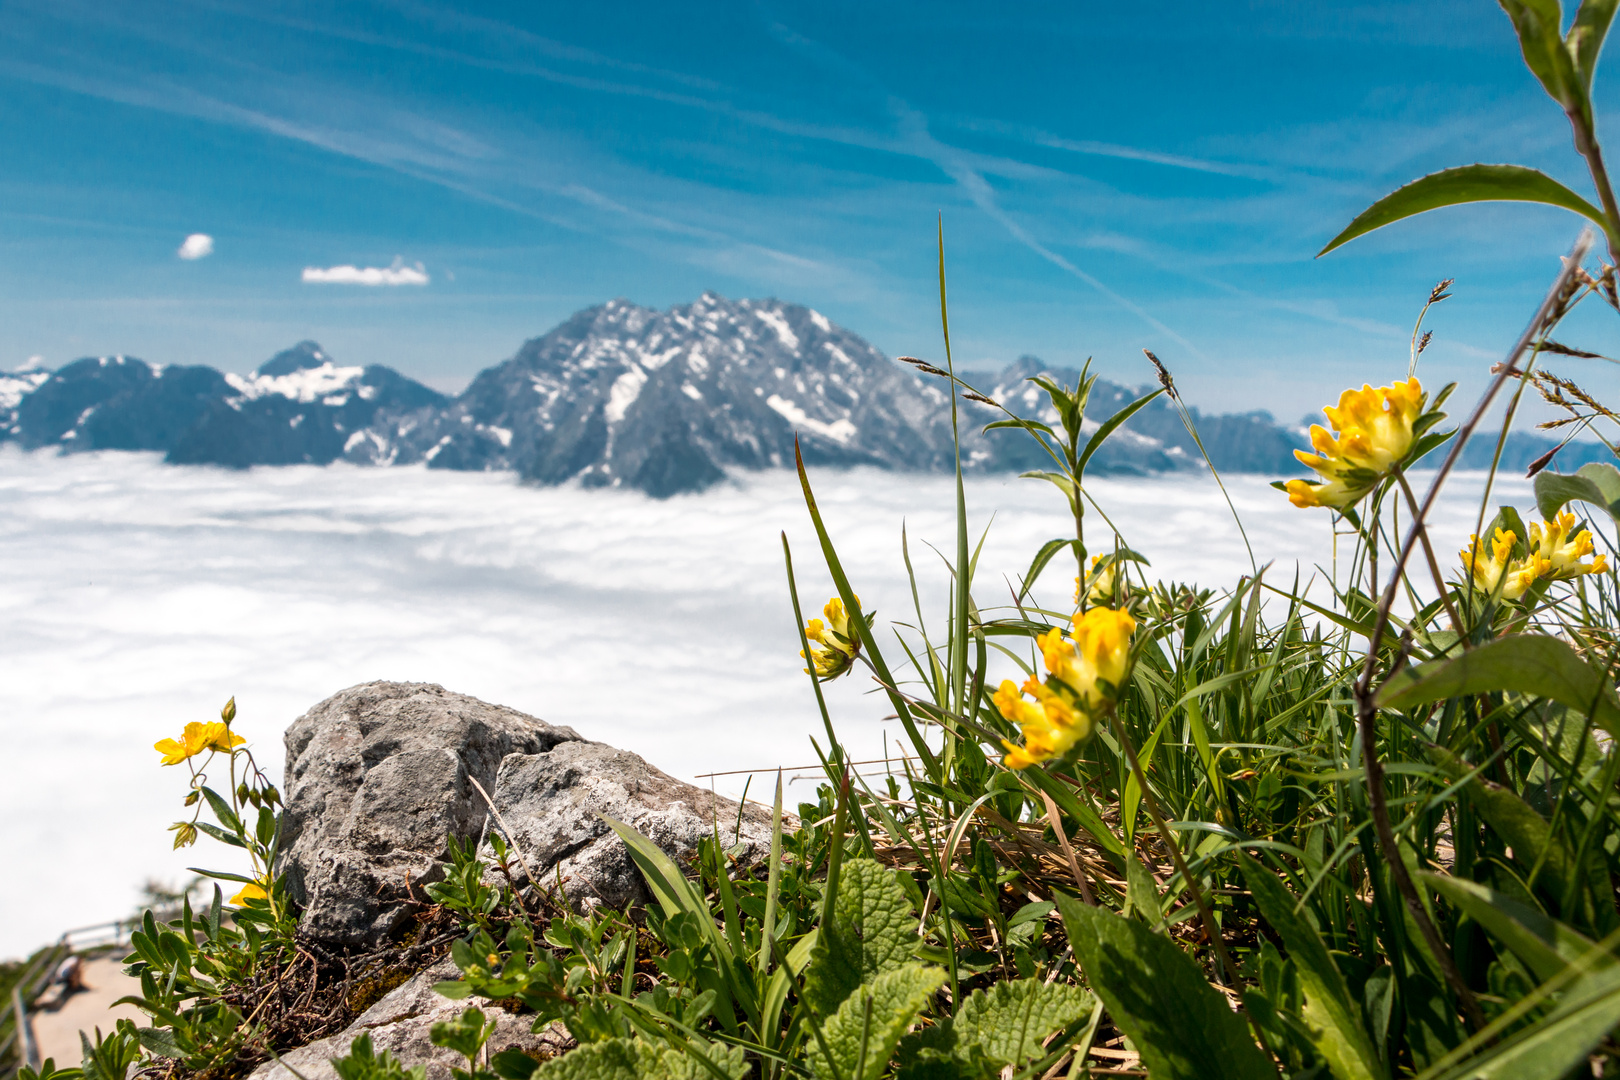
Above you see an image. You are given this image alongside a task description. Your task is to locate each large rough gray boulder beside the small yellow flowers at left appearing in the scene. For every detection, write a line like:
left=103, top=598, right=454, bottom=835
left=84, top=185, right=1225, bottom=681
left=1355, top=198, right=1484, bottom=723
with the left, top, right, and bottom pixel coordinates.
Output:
left=277, top=682, right=770, bottom=946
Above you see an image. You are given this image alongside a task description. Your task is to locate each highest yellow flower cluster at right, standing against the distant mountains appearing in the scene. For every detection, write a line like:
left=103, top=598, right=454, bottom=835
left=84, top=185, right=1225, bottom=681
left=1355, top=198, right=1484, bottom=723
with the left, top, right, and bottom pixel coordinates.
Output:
left=1286, top=377, right=1426, bottom=510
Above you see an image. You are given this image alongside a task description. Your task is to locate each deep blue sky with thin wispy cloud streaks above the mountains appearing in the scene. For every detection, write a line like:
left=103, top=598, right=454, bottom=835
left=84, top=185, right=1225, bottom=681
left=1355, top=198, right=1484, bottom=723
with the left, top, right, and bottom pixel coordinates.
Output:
left=0, top=0, right=1617, bottom=419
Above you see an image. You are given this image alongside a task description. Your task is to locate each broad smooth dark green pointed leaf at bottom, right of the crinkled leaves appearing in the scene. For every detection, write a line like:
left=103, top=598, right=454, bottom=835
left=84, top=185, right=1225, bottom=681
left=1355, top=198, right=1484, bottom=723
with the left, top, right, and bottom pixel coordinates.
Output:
left=1056, top=892, right=1277, bottom=1080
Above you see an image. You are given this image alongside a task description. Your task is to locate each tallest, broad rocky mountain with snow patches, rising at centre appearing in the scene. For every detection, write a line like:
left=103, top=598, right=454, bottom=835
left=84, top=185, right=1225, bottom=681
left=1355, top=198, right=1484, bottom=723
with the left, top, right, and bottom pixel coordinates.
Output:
left=398, top=293, right=949, bottom=495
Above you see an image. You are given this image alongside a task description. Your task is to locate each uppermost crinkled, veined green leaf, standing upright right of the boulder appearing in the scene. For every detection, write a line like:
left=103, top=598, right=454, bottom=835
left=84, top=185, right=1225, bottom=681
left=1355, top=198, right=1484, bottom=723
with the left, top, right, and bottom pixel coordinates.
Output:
left=803, top=858, right=917, bottom=1017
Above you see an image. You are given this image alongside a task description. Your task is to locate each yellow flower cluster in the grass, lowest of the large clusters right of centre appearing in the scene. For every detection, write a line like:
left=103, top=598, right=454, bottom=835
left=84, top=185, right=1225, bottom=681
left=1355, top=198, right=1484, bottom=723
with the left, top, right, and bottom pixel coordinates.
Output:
left=995, top=607, right=1136, bottom=769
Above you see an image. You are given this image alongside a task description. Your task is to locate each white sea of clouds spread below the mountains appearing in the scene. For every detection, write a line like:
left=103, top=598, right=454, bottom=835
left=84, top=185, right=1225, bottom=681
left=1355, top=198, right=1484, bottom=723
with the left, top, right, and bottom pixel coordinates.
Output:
left=0, top=450, right=1531, bottom=957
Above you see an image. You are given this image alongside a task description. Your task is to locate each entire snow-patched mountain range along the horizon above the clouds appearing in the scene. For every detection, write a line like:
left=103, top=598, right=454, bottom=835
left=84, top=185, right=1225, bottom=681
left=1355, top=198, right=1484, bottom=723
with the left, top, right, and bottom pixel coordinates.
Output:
left=0, top=293, right=1607, bottom=497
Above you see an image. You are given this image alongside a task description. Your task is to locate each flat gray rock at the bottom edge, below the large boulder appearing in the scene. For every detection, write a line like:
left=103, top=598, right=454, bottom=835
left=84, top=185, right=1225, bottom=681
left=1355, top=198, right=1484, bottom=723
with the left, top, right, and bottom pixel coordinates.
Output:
left=239, top=960, right=573, bottom=1080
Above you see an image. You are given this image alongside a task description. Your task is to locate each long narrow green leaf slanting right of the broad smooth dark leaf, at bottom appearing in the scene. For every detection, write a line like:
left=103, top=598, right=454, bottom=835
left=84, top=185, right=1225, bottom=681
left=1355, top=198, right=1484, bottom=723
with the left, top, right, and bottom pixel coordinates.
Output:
left=1238, top=853, right=1388, bottom=1080
